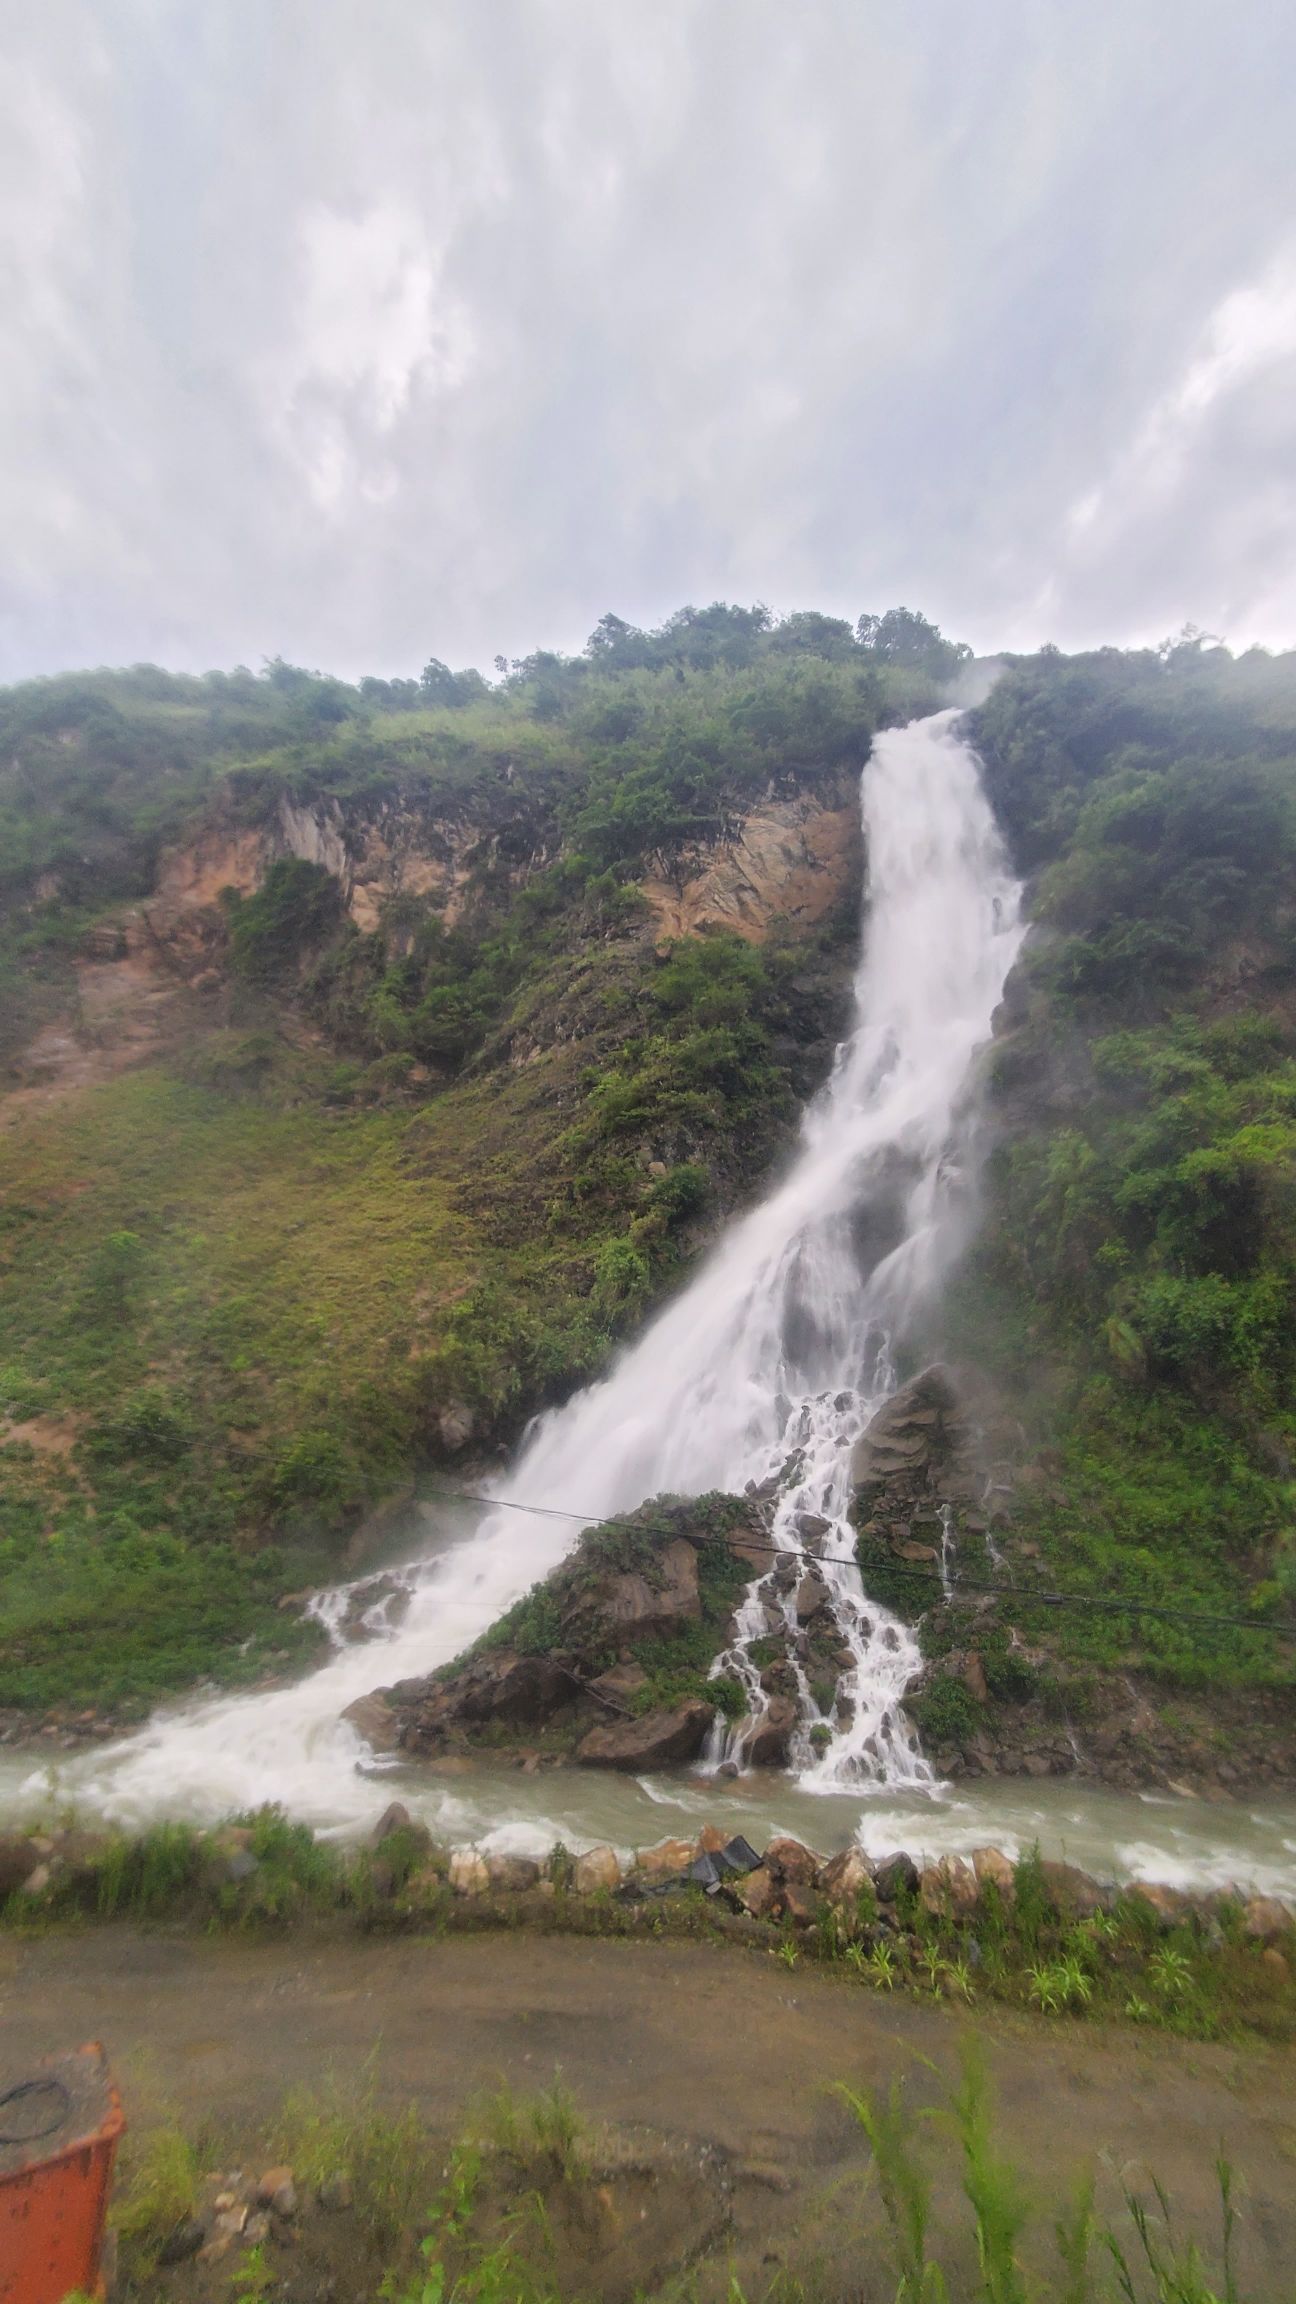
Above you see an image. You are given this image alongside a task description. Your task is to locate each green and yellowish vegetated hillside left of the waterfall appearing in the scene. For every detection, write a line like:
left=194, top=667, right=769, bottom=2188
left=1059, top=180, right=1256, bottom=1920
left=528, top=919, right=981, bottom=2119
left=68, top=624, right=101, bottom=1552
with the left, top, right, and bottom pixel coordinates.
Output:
left=0, top=606, right=950, bottom=1707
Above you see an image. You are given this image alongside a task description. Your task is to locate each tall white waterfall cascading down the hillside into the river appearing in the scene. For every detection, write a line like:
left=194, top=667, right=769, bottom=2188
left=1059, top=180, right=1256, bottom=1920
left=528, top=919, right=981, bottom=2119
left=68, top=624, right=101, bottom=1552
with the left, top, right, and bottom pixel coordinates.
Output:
left=37, top=712, right=1022, bottom=1822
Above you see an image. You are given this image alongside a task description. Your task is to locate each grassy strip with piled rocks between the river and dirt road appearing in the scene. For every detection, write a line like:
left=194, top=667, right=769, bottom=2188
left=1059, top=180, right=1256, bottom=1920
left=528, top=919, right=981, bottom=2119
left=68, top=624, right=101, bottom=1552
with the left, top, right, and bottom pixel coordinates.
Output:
left=0, top=1804, right=1296, bottom=2041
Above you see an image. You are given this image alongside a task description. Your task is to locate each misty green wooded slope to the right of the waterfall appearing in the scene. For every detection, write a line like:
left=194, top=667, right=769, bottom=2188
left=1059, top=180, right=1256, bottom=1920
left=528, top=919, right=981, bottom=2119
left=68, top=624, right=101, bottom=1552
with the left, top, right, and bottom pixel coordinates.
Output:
left=936, top=638, right=1296, bottom=1687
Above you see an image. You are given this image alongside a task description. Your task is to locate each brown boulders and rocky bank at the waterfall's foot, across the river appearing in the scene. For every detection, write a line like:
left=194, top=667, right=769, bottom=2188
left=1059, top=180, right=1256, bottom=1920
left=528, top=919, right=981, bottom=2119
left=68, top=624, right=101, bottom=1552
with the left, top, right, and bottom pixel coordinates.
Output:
left=346, top=1366, right=1296, bottom=1797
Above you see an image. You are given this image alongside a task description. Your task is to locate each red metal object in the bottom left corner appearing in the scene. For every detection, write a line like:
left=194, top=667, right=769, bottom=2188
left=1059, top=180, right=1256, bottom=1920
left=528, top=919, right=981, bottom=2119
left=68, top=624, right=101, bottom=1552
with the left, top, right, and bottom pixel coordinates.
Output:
left=0, top=2041, right=127, bottom=2304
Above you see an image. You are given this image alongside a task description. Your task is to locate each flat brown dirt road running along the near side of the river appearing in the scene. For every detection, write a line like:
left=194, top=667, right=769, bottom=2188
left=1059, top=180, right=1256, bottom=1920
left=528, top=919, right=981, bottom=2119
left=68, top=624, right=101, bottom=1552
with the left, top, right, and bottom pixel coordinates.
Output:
left=0, top=1926, right=1296, bottom=2299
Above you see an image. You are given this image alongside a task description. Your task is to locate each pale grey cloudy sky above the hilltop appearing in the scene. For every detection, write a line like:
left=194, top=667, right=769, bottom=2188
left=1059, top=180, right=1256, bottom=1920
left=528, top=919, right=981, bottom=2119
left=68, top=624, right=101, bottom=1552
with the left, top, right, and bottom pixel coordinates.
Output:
left=0, top=0, right=1296, bottom=677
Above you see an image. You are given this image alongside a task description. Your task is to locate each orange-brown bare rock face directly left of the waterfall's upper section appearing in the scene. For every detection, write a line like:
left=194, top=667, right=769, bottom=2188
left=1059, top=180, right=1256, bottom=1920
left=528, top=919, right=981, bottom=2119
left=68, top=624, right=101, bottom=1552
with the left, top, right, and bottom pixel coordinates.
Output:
left=641, top=793, right=862, bottom=945
